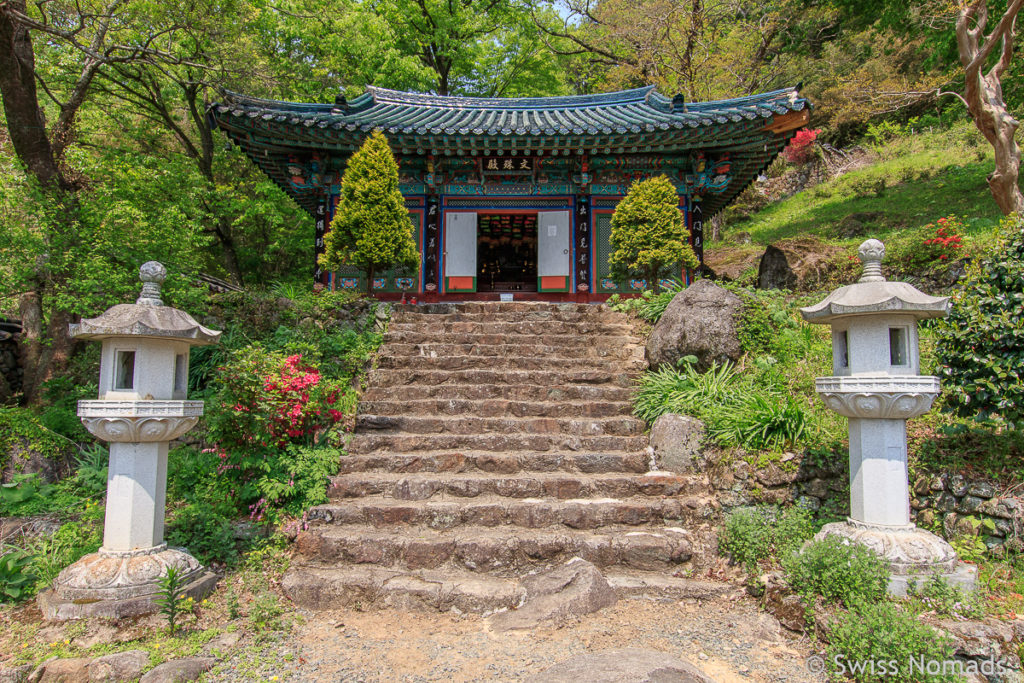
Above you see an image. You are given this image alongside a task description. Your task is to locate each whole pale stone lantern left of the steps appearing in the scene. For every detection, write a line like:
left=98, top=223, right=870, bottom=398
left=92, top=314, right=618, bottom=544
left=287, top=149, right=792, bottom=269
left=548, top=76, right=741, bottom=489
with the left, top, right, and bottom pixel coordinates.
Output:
left=39, top=261, right=220, bottom=620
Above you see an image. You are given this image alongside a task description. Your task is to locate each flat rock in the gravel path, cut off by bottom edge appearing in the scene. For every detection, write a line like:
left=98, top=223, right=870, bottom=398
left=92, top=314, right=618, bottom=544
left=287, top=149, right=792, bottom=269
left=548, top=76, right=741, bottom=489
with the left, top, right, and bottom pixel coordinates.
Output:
left=530, top=647, right=713, bottom=683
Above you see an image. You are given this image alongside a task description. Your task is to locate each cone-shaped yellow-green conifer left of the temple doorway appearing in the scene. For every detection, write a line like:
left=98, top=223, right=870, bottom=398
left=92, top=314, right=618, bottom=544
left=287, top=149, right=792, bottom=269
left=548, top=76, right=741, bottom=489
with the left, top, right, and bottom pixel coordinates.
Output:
left=321, top=130, right=420, bottom=294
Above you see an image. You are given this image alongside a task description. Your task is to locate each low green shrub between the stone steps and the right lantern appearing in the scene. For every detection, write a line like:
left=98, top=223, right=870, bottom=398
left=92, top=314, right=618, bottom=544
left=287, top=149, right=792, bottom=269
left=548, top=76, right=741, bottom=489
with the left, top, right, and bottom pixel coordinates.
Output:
left=719, top=506, right=814, bottom=574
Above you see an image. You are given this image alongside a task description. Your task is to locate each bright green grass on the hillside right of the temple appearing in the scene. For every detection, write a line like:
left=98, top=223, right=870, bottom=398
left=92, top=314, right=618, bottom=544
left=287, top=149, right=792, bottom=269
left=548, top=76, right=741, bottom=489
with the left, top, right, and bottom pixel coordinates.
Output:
left=724, top=122, right=1001, bottom=249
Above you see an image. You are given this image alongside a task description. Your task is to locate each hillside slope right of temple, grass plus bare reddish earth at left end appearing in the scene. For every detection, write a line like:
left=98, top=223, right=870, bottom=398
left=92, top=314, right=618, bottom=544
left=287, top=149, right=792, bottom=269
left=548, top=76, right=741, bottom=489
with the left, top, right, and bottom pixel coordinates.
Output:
left=707, top=122, right=1001, bottom=280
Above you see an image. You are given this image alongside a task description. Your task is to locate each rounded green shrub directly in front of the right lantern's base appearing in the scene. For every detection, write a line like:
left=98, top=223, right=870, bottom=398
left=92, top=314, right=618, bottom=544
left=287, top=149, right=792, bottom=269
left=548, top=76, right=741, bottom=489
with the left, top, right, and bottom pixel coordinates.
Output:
left=782, top=537, right=889, bottom=607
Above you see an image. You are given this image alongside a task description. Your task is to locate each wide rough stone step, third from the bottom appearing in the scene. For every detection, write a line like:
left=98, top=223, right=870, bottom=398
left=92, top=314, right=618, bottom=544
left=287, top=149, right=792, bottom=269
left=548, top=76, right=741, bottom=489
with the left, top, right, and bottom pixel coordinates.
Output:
left=308, top=495, right=718, bottom=529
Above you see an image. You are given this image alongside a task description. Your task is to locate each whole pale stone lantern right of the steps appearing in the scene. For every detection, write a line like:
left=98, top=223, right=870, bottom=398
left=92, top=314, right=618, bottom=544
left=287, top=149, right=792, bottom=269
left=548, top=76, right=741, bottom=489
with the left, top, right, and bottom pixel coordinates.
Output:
left=801, top=240, right=977, bottom=595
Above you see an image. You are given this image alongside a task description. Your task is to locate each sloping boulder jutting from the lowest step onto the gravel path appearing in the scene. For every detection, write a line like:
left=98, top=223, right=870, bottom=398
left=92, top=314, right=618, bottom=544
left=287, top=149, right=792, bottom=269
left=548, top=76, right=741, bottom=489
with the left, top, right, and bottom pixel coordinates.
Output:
left=489, top=558, right=618, bottom=631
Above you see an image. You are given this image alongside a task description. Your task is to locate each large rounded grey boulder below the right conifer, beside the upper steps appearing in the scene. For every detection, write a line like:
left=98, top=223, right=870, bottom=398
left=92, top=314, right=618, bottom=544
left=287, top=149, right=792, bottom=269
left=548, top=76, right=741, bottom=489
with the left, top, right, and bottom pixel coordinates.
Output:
left=647, top=280, right=743, bottom=372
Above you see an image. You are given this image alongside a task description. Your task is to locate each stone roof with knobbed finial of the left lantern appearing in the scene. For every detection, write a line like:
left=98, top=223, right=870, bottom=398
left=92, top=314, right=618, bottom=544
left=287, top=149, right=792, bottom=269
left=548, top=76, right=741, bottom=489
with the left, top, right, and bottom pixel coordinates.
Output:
left=69, top=261, right=220, bottom=346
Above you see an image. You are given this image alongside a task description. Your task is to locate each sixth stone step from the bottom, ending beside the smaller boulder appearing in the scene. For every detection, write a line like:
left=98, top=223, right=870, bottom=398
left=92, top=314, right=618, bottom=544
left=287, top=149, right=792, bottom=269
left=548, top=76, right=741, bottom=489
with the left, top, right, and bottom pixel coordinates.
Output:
left=348, top=432, right=649, bottom=455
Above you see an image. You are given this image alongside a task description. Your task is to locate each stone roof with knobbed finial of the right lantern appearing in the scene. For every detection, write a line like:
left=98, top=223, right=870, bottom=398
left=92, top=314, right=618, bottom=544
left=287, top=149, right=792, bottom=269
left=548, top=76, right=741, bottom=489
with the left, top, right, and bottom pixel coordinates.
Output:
left=800, top=240, right=949, bottom=324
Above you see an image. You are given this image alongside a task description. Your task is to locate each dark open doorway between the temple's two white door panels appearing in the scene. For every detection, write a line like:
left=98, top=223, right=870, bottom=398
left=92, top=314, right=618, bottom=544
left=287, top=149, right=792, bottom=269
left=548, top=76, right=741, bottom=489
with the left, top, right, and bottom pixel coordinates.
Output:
left=476, top=213, right=537, bottom=292
